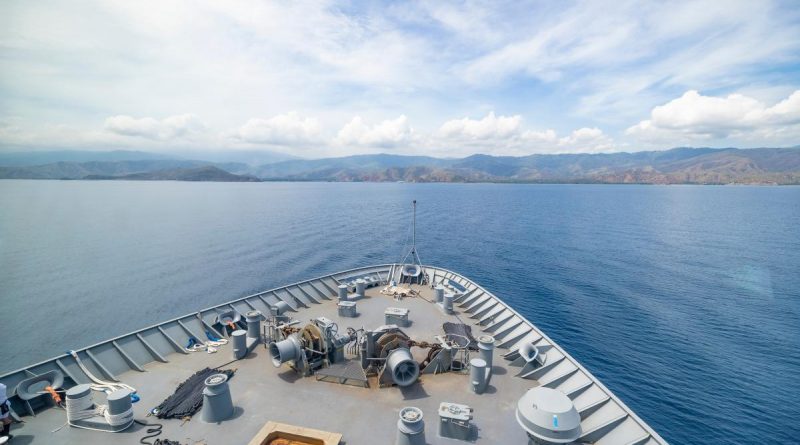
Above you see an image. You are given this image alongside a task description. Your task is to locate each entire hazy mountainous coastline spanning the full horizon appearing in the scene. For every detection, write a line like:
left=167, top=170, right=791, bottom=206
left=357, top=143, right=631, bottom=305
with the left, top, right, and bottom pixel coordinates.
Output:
left=0, top=147, right=800, bottom=184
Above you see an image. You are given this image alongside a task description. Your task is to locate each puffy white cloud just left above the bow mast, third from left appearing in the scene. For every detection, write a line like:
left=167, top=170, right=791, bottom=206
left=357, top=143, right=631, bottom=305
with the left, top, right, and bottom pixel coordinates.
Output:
left=334, top=115, right=415, bottom=148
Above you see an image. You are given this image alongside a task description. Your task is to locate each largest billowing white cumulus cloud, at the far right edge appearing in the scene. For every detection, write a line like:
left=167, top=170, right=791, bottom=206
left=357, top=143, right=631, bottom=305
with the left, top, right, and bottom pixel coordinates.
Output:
left=625, top=90, right=800, bottom=141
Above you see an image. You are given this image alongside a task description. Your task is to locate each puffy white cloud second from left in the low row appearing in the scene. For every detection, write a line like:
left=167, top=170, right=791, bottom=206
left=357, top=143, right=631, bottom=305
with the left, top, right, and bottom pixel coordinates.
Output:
left=236, top=111, right=320, bottom=145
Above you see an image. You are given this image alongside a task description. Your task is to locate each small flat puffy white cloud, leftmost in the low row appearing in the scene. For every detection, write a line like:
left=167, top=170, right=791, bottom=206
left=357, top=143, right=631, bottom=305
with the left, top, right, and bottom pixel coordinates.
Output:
left=105, top=114, right=205, bottom=140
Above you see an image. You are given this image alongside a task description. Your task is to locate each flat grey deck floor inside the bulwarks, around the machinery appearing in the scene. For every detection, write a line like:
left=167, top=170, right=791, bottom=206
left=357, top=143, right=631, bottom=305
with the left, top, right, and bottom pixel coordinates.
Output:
left=12, top=287, right=536, bottom=445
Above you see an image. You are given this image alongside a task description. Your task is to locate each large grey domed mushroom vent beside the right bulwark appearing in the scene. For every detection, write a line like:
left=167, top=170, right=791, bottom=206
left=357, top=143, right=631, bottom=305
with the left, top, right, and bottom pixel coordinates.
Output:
left=517, top=386, right=581, bottom=445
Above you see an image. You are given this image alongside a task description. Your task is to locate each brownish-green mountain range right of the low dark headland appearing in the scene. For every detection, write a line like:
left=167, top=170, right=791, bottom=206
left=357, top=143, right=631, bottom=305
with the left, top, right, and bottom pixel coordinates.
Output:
left=254, top=148, right=800, bottom=184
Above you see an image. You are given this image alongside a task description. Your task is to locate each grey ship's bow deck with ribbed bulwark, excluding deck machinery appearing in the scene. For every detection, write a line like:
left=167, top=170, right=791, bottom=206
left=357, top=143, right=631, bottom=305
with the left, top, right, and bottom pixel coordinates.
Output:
left=0, top=265, right=666, bottom=445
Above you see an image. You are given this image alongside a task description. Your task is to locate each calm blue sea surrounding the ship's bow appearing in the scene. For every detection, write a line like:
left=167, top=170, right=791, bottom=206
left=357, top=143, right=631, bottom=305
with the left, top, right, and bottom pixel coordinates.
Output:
left=0, top=180, right=800, bottom=444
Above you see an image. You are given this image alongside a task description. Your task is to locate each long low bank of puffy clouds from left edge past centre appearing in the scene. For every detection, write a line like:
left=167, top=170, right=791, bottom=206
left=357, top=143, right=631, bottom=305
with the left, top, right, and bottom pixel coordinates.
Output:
left=0, top=112, right=617, bottom=157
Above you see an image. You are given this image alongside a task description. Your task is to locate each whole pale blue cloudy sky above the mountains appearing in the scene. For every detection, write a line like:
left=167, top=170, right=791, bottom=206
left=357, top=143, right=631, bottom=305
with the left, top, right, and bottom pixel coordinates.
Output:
left=0, top=0, right=800, bottom=158
